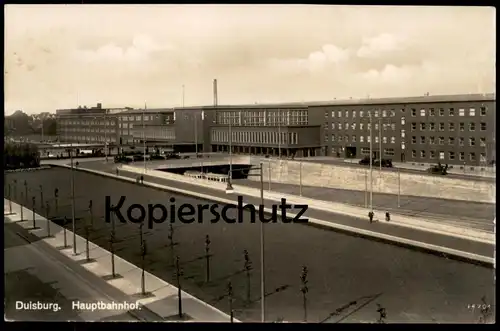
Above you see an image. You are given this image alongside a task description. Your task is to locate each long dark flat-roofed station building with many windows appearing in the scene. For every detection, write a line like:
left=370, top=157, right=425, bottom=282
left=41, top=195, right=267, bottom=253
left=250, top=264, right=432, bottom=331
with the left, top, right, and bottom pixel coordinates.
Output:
left=56, top=94, right=496, bottom=166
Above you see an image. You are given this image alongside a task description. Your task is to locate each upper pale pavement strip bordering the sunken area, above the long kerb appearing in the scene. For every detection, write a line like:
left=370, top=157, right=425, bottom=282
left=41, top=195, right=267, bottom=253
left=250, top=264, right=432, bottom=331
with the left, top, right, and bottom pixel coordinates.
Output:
left=121, top=166, right=495, bottom=243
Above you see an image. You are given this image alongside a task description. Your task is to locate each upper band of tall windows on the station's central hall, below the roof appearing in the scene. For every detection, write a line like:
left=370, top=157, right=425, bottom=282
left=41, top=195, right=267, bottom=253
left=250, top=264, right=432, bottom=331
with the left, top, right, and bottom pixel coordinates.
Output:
left=216, top=109, right=309, bottom=126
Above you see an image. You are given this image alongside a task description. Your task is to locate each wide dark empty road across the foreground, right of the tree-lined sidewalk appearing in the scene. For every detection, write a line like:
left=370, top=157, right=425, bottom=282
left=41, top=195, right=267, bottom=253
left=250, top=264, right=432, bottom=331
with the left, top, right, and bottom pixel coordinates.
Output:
left=6, top=169, right=494, bottom=323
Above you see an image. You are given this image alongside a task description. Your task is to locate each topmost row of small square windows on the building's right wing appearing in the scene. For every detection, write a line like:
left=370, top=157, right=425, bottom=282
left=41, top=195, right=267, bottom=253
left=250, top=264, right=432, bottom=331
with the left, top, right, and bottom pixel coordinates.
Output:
left=325, top=106, right=486, bottom=118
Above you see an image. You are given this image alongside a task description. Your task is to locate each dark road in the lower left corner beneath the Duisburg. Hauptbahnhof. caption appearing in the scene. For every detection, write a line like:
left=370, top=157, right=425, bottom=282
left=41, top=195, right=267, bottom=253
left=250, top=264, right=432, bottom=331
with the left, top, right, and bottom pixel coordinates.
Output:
left=4, top=223, right=163, bottom=321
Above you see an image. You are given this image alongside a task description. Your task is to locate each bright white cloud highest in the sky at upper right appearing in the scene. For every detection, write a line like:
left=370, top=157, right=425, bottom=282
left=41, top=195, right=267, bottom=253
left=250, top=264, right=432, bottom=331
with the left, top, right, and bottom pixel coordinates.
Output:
left=356, top=33, right=406, bottom=58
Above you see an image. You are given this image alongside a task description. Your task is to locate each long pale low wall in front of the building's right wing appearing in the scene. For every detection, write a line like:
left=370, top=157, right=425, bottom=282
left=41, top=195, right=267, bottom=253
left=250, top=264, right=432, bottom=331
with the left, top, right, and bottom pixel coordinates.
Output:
left=249, top=158, right=496, bottom=203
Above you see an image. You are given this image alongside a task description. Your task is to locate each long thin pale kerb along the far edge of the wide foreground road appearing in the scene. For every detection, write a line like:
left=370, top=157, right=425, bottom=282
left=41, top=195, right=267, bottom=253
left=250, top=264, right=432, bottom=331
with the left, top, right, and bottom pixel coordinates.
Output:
left=48, top=165, right=495, bottom=268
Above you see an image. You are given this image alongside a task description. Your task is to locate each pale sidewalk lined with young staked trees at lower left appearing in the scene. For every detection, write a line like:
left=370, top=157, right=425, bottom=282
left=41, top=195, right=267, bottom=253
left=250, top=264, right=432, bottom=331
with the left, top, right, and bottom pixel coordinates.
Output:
left=4, top=199, right=239, bottom=322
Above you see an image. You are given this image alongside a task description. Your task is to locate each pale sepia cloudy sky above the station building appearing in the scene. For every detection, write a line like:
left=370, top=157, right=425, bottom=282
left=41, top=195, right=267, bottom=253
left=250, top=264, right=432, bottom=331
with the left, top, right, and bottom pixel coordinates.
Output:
left=4, top=5, right=496, bottom=113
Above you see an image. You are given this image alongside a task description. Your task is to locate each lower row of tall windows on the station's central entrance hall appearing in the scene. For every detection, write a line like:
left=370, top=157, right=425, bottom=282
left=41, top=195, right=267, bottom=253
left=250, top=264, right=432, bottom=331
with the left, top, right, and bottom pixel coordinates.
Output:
left=211, top=129, right=299, bottom=145
